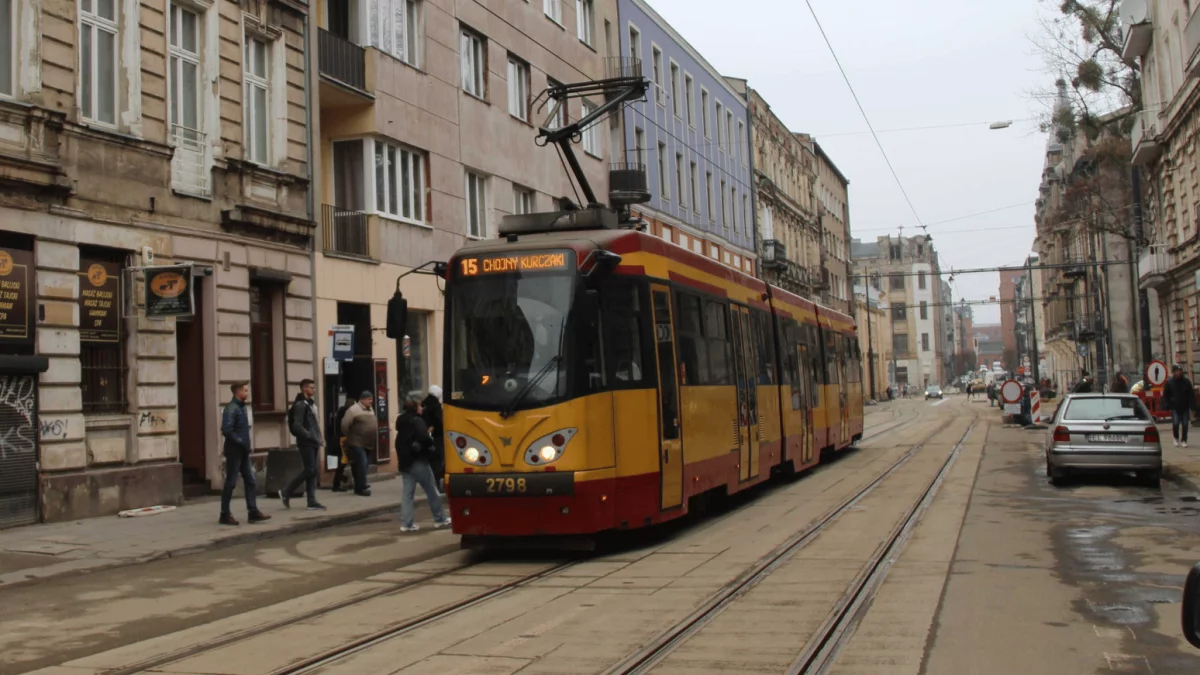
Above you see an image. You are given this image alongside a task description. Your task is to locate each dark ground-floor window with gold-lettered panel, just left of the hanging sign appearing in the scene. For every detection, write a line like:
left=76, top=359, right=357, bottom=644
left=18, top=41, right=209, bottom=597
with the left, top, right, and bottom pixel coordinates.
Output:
left=79, top=246, right=128, bottom=414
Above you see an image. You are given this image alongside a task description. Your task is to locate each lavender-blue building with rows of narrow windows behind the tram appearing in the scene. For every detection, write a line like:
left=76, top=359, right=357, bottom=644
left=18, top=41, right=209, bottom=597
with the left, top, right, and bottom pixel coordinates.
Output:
left=613, top=0, right=755, bottom=274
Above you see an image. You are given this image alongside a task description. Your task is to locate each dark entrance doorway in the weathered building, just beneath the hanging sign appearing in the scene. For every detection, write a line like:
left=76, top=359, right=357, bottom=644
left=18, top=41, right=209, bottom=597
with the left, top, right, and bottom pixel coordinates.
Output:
left=175, top=283, right=210, bottom=491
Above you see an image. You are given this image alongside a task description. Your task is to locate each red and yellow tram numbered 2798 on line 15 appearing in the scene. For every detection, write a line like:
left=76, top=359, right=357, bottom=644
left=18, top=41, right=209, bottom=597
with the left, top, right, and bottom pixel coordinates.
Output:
left=444, top=229, right=863, bottom=544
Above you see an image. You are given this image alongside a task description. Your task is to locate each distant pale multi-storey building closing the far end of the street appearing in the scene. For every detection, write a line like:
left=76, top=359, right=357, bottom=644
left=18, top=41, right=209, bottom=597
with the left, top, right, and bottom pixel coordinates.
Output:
left=851, top=235, right=947, bottom=387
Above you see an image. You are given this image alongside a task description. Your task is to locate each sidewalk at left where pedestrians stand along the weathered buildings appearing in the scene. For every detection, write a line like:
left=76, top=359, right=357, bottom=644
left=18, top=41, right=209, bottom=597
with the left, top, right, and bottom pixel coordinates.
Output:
left=0, top=477, right=408, bottom=590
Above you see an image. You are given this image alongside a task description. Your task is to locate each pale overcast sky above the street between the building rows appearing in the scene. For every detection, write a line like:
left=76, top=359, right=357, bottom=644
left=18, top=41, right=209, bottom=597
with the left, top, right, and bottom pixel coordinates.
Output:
left=649, top=0, right=1052, bottom=322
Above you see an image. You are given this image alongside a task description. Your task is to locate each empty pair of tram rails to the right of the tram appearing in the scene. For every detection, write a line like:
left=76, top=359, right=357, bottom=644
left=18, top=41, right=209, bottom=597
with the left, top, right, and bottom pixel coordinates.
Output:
left=605, top=410, right=976, bottom=675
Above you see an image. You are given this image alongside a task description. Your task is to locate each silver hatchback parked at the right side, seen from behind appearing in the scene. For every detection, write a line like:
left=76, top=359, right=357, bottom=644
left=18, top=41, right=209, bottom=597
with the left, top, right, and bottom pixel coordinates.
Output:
left=1045, top=394, right=1163, bottom=488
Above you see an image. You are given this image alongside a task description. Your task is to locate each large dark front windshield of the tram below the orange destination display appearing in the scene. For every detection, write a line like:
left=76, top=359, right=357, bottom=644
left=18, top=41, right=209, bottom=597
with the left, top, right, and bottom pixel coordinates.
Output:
left=448, top=271, right=576, bottom=410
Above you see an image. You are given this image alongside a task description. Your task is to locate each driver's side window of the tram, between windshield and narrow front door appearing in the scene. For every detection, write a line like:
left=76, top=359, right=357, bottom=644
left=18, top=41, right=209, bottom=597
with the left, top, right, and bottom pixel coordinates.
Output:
left=600, top=283, right=650, bottom=389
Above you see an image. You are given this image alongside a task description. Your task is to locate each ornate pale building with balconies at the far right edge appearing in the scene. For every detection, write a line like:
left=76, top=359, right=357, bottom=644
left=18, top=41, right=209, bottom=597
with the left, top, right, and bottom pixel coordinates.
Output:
left=1122, top=0, right=1200, bottom=382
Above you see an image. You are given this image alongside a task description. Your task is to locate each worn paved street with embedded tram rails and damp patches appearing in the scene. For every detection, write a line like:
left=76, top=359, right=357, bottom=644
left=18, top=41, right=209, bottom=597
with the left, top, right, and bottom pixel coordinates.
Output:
left=9, top=395, right=1200, bottom=675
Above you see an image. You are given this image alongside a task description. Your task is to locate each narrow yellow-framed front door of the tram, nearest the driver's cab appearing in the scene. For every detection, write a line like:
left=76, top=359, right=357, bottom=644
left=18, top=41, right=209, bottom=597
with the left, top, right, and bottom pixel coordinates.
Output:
left=650, top=285, right=683, bottom=510
